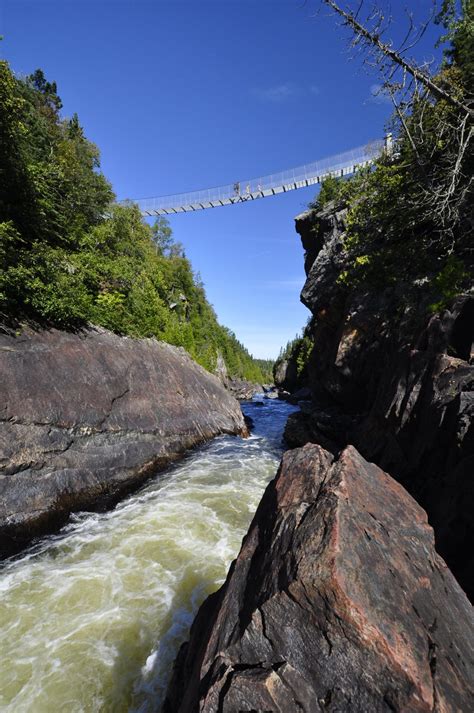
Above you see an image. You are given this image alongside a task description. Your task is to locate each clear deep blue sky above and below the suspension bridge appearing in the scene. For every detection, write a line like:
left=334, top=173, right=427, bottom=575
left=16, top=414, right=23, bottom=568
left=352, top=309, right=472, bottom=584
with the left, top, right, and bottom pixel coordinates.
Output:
left=0, top=0, right=440, bottom=357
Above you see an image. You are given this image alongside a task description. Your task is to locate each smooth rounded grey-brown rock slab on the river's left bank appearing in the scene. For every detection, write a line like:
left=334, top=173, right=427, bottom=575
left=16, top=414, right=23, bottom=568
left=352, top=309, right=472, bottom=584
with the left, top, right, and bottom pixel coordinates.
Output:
left=0, top=329, right=246, bottom=555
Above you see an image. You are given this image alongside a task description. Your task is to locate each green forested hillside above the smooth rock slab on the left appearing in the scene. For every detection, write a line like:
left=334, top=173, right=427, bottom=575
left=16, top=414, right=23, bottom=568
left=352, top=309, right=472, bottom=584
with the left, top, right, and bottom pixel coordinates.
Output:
left=0, top=61, right=269, bottom=382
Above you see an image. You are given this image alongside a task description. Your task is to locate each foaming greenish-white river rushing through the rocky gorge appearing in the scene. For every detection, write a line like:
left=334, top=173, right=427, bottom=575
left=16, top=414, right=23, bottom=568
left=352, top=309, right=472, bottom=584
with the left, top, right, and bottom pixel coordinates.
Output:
left=0, top=400, right=295, bottom=713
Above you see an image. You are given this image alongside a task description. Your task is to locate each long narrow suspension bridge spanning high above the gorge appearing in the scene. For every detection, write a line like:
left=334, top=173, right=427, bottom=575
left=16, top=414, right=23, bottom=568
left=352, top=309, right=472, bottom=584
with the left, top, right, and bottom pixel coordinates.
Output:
left=128, top=135, right=392, bottom=217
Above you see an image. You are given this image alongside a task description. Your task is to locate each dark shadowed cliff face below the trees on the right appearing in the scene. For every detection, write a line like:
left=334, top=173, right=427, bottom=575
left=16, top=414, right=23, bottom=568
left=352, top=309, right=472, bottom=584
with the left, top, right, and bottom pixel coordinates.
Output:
left=287, top=206, right=474, bottom=597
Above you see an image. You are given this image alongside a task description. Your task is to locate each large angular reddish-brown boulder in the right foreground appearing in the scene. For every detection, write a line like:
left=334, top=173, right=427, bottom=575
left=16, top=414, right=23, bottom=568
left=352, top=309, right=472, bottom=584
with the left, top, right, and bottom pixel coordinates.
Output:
left=164, top=444, right=474, bottom=713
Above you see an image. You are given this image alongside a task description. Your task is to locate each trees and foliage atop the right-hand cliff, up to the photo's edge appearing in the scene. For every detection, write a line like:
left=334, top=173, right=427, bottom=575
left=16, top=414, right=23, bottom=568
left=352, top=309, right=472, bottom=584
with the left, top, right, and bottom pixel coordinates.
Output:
left=312, top=0, right=474, bottom=309
